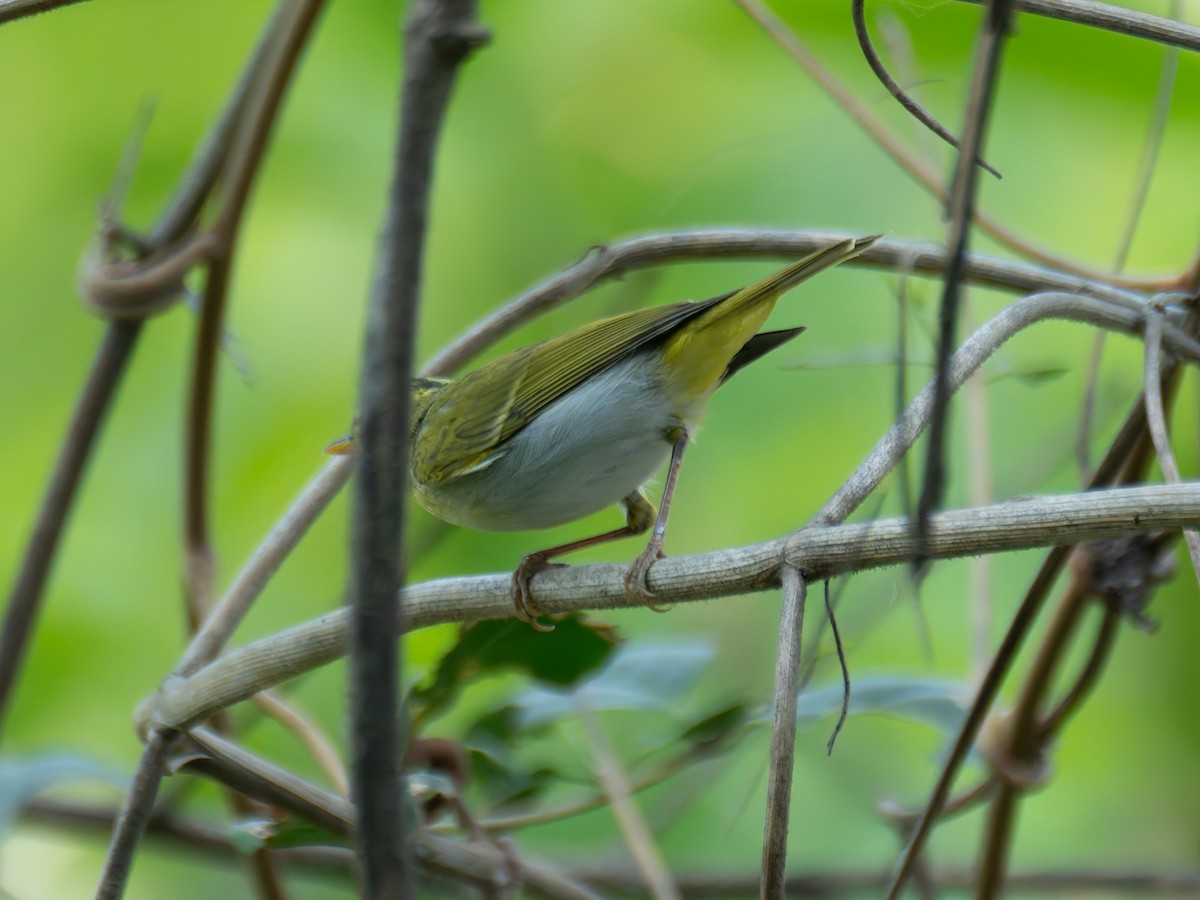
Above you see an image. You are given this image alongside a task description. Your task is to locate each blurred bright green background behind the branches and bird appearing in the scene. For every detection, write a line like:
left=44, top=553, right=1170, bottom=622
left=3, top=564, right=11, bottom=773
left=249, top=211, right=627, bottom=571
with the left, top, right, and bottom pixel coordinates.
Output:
left=0, top=0, right=1200, bottom=898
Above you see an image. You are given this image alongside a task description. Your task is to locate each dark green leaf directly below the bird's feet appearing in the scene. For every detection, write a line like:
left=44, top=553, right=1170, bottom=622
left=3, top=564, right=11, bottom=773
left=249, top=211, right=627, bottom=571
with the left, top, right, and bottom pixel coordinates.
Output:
left=412, top=613, right=617, bottom=722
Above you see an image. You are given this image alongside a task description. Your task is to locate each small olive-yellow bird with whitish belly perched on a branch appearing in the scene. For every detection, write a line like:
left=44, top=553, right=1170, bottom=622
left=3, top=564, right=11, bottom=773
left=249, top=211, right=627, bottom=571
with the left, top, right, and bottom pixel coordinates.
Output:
left=326, top=236, right=876, bottom=626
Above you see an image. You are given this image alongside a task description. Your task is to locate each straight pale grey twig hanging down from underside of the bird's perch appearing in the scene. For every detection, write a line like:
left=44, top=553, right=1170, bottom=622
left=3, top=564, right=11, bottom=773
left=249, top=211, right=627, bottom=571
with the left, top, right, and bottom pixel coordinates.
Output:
left=760, top=565, right=808, bottom=898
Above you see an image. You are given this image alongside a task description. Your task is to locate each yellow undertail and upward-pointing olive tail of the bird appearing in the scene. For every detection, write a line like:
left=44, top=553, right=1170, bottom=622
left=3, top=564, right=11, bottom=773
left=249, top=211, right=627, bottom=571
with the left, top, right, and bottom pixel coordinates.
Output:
left=662, top=238, right=875, bottom=412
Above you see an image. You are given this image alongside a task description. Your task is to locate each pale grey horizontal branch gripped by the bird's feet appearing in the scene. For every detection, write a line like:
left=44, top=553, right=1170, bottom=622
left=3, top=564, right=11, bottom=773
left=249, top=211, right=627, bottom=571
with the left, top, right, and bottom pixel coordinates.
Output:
left=138, top=482, right=1200, bottom=730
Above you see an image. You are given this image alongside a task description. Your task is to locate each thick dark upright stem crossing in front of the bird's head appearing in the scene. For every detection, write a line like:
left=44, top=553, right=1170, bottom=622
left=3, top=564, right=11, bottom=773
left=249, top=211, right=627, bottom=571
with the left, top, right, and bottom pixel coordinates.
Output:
left=350, top=0, right=484, bottom=899
